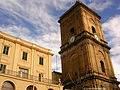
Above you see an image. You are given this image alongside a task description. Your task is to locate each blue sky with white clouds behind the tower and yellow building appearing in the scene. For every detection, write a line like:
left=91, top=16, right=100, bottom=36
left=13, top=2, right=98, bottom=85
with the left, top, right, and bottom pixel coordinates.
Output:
left=0, top=0, right=120, bottom=80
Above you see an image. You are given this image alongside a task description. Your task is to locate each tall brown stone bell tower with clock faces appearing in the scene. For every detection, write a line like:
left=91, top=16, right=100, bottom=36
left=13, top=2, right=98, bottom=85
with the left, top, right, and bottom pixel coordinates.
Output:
left=58, top=1, right=119, bottom=90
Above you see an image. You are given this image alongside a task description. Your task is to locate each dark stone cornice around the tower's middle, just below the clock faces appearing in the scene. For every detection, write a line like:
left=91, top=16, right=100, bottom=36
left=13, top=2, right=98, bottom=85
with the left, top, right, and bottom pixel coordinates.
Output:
left=59, top=31, right=111, bottom=54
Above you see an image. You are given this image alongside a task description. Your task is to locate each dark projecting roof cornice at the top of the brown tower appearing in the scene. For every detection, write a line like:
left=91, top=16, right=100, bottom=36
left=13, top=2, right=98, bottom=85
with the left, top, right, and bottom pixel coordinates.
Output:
left=58, top=0, right=101, bottom=22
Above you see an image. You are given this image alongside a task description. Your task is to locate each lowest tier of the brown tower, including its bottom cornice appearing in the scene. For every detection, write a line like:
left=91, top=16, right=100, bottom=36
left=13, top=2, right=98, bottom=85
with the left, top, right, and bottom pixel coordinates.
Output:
left=63, top=73, right=120, bottom=90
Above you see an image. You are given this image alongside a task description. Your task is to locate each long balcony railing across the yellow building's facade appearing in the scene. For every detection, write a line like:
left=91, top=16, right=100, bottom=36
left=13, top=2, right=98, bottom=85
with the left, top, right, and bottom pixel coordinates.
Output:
left=0, top=70, right=59, bottom=85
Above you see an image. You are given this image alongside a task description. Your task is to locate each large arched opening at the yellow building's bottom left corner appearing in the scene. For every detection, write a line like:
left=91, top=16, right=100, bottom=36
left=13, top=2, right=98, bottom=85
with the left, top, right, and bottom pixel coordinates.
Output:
left=1, top=81, right=15, bottom=90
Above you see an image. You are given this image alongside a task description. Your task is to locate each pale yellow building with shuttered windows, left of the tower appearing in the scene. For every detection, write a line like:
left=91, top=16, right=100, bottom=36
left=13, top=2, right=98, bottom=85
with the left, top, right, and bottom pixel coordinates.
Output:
left=0, top=32, right=63, bottom=90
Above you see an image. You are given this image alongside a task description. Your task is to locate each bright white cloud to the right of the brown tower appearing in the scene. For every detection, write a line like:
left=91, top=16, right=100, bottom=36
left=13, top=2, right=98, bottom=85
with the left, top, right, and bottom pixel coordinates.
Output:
left=102, top=15, right=120, bottom=80
